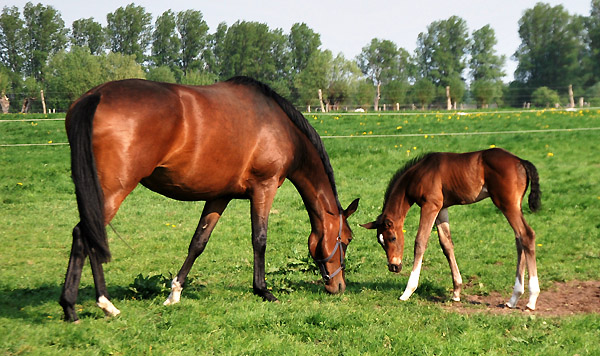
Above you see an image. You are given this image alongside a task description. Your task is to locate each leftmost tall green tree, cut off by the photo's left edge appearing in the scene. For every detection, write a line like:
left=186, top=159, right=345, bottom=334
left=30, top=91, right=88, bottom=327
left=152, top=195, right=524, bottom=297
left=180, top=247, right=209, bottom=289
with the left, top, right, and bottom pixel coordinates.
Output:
left=0, top=6, right=25, bottom=76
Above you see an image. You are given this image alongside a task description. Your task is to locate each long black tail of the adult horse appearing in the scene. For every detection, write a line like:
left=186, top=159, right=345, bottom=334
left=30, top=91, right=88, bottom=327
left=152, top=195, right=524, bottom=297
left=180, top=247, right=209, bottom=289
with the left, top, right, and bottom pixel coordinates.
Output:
left=67, top=94, right=110, bottom=262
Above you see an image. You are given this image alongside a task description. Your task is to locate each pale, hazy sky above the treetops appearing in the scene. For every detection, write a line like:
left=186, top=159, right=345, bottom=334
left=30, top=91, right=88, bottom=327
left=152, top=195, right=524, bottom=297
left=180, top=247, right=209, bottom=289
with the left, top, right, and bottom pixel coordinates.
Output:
left=0, top=0, right=591, bottom=81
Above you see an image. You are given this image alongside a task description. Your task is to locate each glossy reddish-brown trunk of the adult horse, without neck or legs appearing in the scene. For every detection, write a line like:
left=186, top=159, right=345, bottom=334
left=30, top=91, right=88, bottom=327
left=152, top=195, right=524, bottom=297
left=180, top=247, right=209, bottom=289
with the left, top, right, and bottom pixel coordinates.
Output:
left=70, top=80, right=295, bottom=200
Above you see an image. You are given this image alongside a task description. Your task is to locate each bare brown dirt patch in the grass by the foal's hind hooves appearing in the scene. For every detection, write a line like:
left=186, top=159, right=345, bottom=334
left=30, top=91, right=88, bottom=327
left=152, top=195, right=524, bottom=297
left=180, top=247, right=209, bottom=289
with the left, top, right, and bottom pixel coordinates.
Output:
left=446, top=281, right=600, bottom=316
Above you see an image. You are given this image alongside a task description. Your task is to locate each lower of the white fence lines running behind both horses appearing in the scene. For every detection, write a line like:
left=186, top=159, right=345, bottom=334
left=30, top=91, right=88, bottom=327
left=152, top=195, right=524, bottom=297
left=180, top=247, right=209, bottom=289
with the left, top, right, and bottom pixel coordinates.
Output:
left=0, top=127, right=600, bottom=147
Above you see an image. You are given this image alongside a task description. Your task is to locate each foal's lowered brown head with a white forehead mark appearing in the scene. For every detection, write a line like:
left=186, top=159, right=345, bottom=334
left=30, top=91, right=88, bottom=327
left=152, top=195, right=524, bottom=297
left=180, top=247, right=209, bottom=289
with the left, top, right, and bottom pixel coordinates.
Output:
left=361, top=215, right=404, bottom=273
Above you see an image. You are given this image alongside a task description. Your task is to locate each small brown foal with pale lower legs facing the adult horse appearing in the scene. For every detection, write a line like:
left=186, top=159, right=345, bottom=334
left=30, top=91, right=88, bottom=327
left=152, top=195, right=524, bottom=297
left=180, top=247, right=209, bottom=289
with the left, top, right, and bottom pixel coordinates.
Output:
left=362, top=148, right=541, bottom=310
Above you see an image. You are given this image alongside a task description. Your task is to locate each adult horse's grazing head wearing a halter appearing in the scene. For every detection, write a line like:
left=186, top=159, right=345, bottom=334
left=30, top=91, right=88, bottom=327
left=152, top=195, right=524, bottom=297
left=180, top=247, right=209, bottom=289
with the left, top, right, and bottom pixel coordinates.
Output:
left=308, top=199, right=358, bottom=294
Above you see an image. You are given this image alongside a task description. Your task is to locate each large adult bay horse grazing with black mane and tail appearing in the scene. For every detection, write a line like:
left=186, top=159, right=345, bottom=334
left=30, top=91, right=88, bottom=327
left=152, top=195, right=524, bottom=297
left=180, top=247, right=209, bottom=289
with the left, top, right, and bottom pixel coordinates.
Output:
left=60, top=77, right=358, bottom=321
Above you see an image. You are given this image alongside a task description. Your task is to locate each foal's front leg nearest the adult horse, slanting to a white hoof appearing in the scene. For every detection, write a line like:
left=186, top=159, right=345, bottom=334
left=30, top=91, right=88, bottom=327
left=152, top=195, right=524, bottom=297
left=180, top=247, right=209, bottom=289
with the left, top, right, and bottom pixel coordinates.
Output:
left=400, top=204, right=440, bottom=300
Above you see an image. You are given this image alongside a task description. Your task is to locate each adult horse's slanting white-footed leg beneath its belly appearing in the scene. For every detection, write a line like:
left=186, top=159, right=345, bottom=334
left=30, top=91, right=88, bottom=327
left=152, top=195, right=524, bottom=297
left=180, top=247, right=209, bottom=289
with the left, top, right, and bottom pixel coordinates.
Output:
left=163, top=199, right=230, bottom=305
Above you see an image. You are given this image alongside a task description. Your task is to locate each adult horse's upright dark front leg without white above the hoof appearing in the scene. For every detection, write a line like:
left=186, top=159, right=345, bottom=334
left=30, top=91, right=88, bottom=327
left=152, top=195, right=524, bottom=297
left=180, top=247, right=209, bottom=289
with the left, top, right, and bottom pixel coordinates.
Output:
left=250, top=185, right=277, bottom=302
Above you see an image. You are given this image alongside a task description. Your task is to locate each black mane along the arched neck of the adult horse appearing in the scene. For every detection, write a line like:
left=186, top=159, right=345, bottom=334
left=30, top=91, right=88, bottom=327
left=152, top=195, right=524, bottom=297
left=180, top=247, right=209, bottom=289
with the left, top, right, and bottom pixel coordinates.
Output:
left=227, top=76, right=342, bottom=211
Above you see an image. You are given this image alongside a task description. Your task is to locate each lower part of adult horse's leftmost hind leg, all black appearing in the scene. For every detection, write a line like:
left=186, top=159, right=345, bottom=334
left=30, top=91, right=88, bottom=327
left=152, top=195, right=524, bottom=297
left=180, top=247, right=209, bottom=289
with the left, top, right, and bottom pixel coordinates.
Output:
left=60, top=225, right=86, bottom=322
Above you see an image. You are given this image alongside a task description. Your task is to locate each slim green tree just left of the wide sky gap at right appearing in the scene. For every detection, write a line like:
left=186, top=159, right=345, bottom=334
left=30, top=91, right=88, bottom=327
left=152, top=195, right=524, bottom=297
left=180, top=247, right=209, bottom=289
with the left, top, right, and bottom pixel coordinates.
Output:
left=469, top=25, right=506, bottom=82
